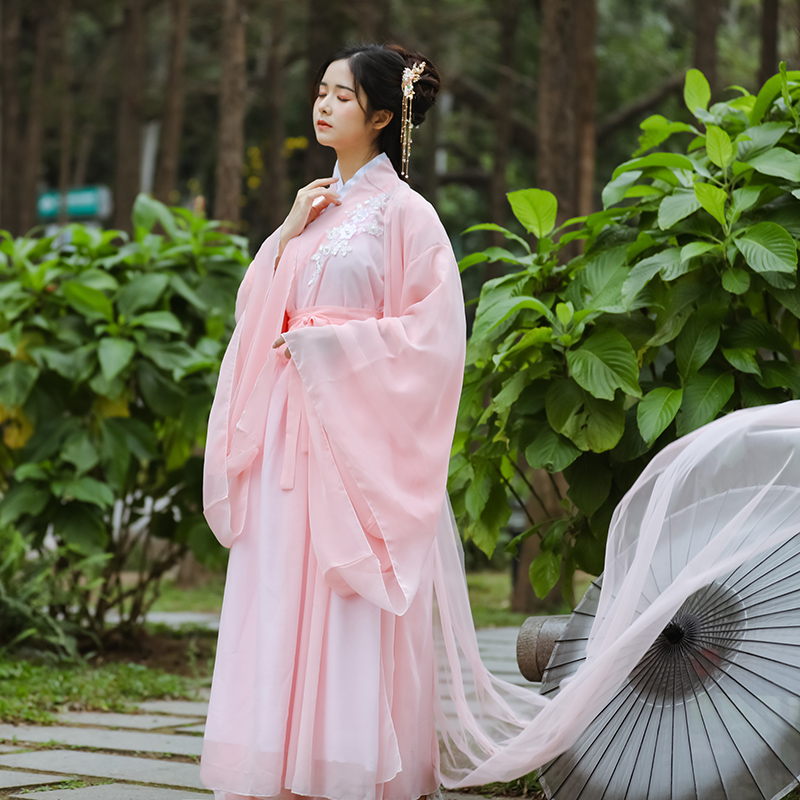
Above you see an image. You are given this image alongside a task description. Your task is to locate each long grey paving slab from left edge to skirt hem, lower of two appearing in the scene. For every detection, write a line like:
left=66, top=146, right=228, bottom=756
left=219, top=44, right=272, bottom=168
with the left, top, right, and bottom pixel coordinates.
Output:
left=0, top=748, right=205, bottom=790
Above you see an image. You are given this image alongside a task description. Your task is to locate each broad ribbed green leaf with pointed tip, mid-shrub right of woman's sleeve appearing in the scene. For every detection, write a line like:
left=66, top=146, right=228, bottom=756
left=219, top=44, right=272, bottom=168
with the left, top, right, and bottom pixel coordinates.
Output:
left=566, top=330, right=641, bottom=400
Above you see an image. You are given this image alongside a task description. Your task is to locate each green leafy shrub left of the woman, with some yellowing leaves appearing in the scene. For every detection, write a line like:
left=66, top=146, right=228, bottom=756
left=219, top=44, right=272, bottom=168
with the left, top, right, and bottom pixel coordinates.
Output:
left=0, top=195, right=249, bottom=641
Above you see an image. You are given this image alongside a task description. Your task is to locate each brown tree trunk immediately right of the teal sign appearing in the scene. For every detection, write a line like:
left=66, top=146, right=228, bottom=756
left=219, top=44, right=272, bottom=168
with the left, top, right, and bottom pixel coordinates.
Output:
left=114, top=0, right=145, bottom=232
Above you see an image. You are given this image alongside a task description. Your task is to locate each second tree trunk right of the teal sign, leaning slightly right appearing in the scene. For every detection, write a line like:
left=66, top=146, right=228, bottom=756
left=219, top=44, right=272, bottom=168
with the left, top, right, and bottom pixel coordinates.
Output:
left=154, top=0, right=189, bottom=203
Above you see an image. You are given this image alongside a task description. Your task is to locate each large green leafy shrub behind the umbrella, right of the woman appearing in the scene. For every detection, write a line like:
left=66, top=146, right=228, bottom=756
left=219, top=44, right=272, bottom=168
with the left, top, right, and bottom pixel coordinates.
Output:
left=450, top=67, right=800, bottom=596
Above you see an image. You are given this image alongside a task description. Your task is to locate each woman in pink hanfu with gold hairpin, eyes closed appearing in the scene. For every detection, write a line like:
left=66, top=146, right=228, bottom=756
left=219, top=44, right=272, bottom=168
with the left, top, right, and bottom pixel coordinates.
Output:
left=201, top=45, right=523, bottom=800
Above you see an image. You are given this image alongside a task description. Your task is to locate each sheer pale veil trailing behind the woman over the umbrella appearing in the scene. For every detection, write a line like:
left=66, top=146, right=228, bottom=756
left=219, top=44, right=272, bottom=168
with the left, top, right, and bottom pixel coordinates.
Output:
left=434, top=401, right=800, bottom=788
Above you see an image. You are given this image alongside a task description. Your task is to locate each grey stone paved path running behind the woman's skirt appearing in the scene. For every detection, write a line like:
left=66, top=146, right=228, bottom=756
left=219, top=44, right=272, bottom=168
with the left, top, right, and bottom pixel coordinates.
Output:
left=0, top=614, right=531, bottom=800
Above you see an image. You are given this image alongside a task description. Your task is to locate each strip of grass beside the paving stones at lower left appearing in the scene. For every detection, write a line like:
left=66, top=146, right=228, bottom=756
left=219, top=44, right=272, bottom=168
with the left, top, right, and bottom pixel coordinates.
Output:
left=0, top=659, right=202, bottom=725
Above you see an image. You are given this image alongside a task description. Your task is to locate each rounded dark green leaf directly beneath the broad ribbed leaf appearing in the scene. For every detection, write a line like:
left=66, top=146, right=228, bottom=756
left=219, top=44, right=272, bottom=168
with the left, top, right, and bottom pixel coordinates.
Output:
left=545, top=380, right=625, bottom=453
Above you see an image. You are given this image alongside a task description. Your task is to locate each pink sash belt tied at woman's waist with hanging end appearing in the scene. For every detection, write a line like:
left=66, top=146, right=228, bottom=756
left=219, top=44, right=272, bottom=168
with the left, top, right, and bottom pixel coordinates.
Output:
left=280, top=306, right=381, bottom=489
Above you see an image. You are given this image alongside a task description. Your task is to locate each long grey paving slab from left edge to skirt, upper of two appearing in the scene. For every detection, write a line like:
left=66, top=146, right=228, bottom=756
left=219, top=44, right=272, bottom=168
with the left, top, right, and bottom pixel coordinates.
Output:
left=0, top=724, right=203, bottom=756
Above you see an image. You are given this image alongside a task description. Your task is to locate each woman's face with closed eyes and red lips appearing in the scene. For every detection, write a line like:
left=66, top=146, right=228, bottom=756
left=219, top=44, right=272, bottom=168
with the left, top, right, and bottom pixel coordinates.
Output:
left=314, top=59, right=385, bottom=155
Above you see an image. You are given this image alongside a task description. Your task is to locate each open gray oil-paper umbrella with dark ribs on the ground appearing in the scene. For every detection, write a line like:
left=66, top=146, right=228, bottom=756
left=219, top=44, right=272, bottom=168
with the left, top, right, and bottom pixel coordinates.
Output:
left=540, top=524, right=800, bottom=800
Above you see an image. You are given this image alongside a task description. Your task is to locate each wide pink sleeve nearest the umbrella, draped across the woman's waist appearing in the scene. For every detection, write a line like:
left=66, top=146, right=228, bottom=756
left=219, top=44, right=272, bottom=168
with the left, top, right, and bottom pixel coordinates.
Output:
left=284, top=194, right=465, bottom=614
